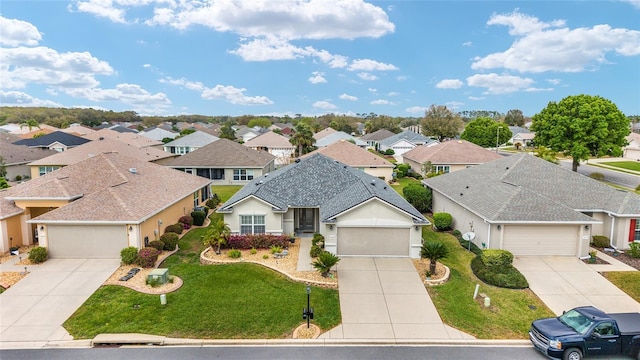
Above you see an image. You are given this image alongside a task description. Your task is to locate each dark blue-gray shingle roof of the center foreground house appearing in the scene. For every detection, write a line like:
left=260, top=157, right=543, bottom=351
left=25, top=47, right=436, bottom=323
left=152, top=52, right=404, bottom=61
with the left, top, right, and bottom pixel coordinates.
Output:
left=218, top=154, right=429, bottom=224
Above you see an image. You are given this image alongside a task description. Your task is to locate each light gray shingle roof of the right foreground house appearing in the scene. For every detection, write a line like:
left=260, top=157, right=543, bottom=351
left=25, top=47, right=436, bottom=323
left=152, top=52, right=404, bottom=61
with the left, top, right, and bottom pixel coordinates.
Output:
left=423, top=153, right=640, bottom=223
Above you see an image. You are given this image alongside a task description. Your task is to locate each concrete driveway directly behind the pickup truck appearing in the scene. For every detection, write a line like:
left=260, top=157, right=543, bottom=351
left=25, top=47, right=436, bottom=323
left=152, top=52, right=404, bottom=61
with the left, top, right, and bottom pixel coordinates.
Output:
left=513, top=256, right=640, bottom=315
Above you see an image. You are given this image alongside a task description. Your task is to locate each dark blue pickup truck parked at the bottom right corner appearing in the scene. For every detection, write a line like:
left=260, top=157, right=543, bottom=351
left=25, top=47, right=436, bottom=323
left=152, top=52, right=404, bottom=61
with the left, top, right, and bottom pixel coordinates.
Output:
left=529, top=306, right=640, bottom=360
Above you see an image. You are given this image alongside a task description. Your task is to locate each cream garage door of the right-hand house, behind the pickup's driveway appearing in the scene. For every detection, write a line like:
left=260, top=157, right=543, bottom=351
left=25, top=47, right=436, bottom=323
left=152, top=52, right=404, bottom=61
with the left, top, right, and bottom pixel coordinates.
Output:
left=503, top=225, right=579, bottom=256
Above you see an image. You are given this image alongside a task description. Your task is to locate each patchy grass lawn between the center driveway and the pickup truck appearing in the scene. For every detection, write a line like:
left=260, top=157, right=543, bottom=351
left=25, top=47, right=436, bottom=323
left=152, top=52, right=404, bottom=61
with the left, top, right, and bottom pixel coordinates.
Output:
left=423, top=228, right=554, bottom=339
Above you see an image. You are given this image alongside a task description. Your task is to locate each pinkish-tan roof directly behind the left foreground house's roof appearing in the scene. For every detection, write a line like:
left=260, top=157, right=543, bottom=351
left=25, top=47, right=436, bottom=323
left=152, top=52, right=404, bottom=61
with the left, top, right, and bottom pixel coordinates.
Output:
left=29, top=138, right=177, bottom=166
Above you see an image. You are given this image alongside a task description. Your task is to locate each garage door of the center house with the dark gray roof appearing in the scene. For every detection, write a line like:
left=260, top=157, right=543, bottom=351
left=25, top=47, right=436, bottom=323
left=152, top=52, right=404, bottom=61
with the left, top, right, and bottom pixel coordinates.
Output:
left=337, top=227, right=410, bottom=257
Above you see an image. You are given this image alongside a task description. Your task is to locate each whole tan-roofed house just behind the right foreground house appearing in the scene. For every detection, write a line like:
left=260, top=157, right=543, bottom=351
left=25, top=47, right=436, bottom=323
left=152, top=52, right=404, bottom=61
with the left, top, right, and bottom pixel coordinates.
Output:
left=402, top=140, right=502, bottom=176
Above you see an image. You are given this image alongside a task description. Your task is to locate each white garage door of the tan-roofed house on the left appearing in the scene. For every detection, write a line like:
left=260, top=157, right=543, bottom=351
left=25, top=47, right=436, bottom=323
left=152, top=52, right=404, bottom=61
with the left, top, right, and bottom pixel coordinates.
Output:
left=47, top=225, right=128, bottom=259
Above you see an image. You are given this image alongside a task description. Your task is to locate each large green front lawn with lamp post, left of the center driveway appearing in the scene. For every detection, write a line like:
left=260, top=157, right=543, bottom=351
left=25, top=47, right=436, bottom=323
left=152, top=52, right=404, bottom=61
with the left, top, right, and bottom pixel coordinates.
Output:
left=64, top=221, right=341, bottom=339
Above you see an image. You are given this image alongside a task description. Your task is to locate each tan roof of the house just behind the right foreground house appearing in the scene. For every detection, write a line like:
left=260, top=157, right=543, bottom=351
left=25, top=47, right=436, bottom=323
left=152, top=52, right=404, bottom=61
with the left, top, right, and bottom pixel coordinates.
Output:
left=402, top=140, right=502, bottom=165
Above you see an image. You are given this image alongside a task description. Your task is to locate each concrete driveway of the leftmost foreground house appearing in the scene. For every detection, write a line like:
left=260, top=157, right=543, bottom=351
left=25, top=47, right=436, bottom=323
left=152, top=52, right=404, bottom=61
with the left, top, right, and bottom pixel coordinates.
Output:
left=0, top=259, right=120, bottom=347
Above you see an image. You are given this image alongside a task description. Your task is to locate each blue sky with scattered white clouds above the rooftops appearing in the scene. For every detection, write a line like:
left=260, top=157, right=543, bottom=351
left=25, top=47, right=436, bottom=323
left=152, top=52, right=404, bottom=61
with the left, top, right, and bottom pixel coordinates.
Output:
left=0, top=0, right=640, bottom=117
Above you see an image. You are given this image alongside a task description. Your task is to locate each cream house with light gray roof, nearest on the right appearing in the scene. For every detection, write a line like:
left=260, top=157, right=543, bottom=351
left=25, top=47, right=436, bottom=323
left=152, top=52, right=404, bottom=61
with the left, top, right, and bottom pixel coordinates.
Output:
left=423, top=153, right=640, bottom=257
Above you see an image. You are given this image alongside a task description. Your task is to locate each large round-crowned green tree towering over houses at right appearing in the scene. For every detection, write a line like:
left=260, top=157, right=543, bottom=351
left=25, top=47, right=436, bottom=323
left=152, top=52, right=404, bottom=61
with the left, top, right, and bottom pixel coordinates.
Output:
left=531, top=94, right=630, bottom=172
